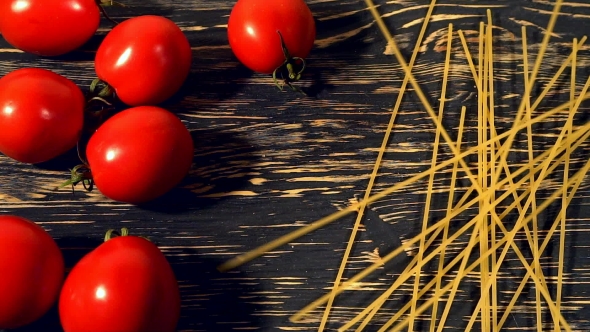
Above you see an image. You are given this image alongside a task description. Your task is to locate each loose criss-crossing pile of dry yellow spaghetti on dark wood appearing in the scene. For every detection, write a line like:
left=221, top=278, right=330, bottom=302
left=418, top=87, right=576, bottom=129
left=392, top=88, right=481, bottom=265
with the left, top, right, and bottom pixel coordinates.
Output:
left=218, top=0, right=590, bottom=332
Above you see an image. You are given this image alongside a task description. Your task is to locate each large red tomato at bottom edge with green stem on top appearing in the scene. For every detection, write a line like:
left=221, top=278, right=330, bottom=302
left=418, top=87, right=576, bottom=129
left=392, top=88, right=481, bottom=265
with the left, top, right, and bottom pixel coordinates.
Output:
left=59, top=232, right=180, bottom=332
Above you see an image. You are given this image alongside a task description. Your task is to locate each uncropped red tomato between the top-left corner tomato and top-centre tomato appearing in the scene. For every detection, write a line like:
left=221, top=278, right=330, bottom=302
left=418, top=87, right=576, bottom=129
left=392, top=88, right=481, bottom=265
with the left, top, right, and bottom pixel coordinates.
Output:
left=94, top=15, right=192, bottom=106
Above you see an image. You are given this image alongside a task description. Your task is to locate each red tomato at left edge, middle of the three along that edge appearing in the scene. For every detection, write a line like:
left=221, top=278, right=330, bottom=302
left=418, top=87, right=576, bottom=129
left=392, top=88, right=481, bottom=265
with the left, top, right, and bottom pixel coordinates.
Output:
left=0, top=68, right=86, bottom=163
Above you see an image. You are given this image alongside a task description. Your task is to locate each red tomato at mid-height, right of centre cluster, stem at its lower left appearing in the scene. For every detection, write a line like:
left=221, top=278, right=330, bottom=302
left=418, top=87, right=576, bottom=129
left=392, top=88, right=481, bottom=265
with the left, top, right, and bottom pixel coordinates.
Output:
left=86, top=106, right=193, bottom=204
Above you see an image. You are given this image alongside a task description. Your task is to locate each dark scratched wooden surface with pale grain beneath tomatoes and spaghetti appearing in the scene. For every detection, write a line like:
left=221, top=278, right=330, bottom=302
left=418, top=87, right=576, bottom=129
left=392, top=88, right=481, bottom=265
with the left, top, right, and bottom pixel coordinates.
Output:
left=0, top=0, right=590, bottom=331
